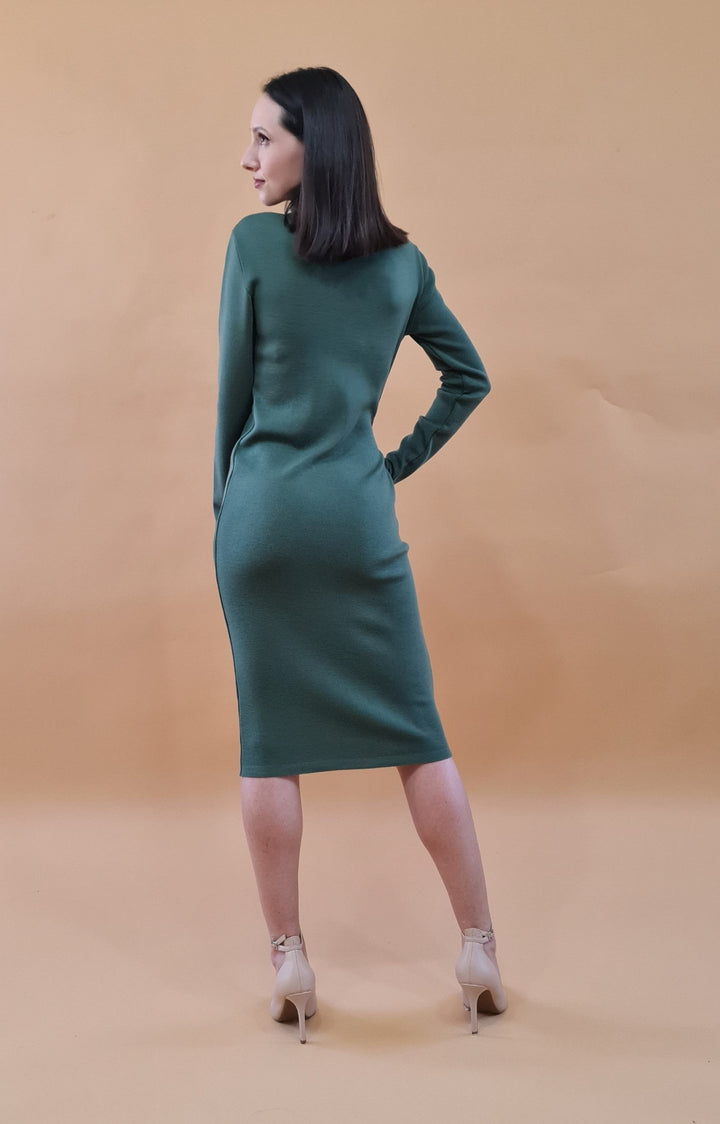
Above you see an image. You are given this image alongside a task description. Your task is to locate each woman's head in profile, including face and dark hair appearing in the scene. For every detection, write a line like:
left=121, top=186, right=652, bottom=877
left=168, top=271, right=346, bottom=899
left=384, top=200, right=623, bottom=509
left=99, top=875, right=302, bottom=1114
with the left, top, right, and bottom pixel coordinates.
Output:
left=243, top=66, right=408, bottom=262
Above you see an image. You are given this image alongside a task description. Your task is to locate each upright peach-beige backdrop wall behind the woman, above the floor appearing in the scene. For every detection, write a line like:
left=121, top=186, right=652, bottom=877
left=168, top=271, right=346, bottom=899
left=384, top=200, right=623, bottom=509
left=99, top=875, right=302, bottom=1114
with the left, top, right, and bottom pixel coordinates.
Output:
left=0, top=0, right=720, bottom=797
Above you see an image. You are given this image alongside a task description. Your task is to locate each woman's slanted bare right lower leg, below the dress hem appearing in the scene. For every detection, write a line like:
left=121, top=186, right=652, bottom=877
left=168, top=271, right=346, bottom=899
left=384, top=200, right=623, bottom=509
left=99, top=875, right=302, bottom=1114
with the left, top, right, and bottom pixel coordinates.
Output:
left=398, top=758, right=494, bottom=959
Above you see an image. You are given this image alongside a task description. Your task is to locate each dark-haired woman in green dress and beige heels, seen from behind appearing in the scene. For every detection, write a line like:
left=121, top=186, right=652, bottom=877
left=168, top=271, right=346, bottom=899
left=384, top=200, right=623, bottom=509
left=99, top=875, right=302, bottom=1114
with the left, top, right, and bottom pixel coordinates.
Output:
left=213, top=67, right=507, bottom=1042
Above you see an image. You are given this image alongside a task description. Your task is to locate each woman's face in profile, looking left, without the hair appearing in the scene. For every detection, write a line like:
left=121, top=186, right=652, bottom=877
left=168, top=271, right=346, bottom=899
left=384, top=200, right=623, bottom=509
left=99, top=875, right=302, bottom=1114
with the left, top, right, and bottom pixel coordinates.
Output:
left=243, top=93, right=304, bottom=207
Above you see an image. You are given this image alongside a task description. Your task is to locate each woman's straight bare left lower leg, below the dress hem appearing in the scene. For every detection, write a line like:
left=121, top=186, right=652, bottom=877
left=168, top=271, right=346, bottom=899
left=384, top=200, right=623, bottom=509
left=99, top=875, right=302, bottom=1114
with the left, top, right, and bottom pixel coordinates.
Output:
left=240, top=777, right=302, bottom=968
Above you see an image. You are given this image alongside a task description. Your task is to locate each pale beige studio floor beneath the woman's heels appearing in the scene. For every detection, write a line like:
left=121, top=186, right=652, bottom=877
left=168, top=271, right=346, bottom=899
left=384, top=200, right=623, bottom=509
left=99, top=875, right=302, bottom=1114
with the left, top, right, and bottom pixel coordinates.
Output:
left=0, top=770, right=720, bottom=1124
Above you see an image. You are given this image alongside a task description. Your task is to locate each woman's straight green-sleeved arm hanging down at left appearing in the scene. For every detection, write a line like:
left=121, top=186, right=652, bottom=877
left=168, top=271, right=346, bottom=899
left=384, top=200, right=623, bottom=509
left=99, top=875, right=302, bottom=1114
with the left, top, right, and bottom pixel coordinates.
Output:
left=212, top=233, right=253, bottom=520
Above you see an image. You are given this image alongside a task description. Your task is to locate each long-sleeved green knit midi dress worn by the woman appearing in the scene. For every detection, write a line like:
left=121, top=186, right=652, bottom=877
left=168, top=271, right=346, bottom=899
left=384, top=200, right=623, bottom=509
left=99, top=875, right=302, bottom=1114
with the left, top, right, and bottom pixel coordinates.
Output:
left=213, top=211, right=490, bottom=777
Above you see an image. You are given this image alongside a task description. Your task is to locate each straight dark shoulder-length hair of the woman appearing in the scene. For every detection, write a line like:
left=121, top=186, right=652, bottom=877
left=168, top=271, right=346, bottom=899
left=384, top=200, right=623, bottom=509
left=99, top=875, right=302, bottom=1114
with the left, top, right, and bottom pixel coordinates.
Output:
left=263, top=66, right=408, bottom=262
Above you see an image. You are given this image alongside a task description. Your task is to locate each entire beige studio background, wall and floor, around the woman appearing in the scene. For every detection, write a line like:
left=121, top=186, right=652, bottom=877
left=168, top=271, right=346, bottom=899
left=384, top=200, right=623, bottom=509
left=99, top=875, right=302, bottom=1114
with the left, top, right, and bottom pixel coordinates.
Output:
left=0, top=0, right=720, bottom=1124
